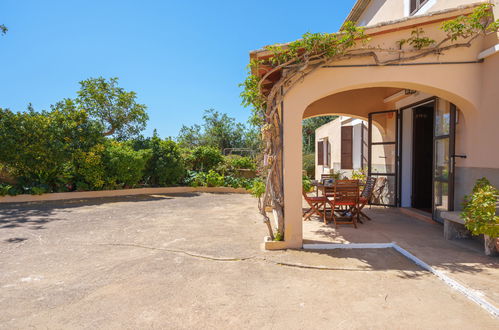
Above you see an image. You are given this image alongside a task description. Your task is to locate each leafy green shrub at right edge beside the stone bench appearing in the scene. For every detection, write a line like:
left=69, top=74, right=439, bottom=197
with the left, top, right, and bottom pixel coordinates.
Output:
left=461, top=178, right=499, bottom=237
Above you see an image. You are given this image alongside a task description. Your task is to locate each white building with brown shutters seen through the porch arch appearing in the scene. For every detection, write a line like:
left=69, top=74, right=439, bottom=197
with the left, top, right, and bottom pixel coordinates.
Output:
left=315, top=116, right=368, bottom=180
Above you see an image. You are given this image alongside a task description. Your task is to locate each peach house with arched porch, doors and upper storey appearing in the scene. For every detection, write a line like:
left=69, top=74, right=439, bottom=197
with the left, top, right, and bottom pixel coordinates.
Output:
left=250, top=0, right=499, bottom=248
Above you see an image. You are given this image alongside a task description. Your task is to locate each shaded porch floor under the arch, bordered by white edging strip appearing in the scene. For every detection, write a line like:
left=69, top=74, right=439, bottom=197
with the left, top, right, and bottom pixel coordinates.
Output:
left=303, top=207, right=499, bottom=314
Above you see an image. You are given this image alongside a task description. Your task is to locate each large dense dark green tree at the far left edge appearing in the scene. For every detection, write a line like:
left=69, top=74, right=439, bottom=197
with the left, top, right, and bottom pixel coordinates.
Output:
left=0, top=101, right=102, bottom=190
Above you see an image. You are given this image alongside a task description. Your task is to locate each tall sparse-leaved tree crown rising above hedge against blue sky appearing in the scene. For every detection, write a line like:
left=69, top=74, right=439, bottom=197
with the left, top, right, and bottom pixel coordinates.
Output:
left=75, top=77, right=149, bottom=139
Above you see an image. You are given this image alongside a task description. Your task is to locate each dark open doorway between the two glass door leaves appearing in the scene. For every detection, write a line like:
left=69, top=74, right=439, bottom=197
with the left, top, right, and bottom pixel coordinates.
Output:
left=412, top=102, right=435, bottom=212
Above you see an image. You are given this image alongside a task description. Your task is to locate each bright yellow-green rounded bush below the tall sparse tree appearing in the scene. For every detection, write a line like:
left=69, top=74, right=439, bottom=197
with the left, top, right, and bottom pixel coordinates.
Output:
left=104, top=141, right=151, bottom=187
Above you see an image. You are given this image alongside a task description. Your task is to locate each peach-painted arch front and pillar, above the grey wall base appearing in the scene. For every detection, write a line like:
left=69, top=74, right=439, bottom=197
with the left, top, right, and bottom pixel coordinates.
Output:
left=283, top=18, right=499, bottom=248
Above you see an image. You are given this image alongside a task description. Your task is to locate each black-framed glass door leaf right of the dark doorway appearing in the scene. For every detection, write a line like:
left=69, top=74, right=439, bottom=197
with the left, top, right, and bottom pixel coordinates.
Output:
left=432, top=99, right=456, bottom=222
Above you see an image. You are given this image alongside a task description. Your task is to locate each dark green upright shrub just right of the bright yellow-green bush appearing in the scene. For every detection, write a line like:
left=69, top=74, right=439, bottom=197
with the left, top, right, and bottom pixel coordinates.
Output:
left=145, top=134, right=185, bottom=186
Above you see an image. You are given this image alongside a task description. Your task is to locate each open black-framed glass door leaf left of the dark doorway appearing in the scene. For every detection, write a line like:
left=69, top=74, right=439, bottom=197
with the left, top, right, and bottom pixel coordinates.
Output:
left=367, top=110, right=399, bottom=206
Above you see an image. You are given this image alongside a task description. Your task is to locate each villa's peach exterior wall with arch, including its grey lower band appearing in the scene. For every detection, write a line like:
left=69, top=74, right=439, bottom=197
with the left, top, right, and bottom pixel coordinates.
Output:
left=254, top=0, right=499, bottom=248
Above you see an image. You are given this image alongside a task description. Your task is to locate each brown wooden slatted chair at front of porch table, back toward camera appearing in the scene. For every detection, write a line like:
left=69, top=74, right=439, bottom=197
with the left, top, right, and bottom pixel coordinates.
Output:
left=325, top=180, right=360, bottom=228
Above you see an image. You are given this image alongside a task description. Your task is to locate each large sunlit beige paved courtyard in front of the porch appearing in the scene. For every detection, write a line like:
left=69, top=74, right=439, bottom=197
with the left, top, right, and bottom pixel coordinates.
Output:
left=0, top=193, right=498, bottom=329
